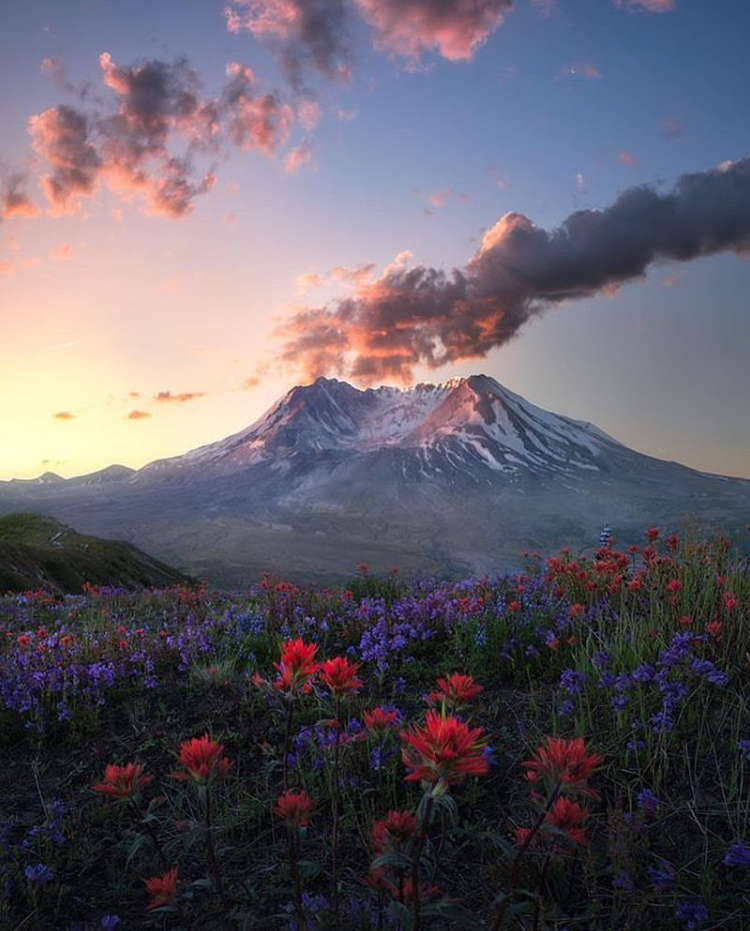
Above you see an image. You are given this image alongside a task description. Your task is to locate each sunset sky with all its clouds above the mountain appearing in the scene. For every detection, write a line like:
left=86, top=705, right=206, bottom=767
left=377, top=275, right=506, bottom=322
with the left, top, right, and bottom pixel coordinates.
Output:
left=0, top=0, right=750, bottom=479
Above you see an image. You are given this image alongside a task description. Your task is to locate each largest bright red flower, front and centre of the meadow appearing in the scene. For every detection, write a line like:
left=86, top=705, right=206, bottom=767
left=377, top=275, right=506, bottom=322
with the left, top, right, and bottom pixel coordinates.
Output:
left=400, top=711, right=490, bottom=786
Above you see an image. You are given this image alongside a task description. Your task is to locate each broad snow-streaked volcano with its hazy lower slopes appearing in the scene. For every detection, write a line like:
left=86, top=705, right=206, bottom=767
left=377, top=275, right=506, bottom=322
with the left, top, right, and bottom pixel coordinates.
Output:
left=0, top=375, right=750, bottom=584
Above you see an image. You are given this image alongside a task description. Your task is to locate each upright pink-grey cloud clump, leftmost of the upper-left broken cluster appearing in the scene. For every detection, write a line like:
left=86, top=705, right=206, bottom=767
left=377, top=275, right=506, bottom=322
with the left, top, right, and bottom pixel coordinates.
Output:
left=29, top=106, right=102, bottom=216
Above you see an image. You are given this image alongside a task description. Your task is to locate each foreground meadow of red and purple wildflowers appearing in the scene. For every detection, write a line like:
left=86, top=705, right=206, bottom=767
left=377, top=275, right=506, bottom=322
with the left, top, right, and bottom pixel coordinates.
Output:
left=0, top=528, right=750, bottom=931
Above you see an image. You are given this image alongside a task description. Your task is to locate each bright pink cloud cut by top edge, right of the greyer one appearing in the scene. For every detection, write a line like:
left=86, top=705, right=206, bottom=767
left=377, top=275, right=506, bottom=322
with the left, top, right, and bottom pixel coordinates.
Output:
left=355, top=0, right=513, bottom=61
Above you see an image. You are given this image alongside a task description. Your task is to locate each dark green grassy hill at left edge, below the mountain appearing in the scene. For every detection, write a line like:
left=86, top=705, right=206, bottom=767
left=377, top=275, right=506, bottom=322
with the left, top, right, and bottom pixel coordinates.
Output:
left=0, top=513, right=188, bottom=593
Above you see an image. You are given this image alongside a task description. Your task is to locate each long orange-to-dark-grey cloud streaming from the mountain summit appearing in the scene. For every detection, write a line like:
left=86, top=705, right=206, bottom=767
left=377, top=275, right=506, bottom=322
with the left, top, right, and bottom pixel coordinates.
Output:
left=279, top=157, right=750, bottom=383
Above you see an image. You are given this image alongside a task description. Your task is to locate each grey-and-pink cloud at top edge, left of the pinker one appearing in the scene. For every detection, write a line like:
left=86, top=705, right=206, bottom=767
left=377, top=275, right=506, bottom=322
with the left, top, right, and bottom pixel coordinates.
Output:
left=224, top=0, right=352, bottom=90
